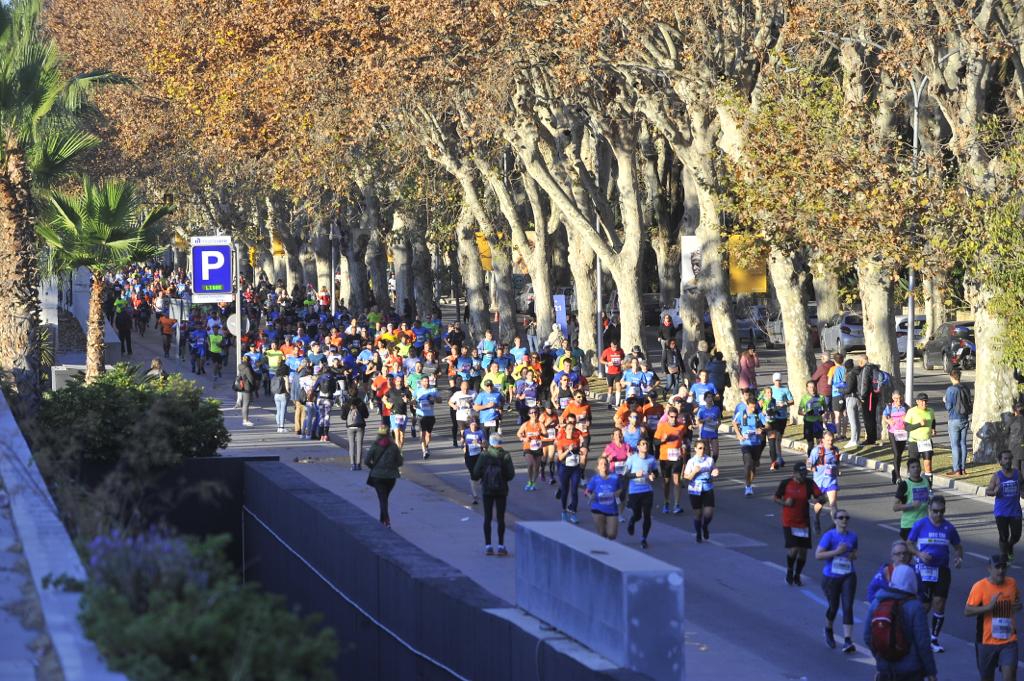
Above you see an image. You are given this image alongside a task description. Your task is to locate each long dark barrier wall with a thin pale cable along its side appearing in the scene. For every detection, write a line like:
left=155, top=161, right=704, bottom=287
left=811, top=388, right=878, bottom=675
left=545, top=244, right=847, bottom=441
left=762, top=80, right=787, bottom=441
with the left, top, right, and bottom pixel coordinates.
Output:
left=243, top=463, right=649, bottom=681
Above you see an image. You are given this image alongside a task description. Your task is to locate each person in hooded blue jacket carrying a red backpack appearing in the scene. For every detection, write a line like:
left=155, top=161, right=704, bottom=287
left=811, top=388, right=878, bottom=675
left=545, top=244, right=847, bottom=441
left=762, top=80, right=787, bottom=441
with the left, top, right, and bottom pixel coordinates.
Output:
left=864, top=565, right=938, bottom=681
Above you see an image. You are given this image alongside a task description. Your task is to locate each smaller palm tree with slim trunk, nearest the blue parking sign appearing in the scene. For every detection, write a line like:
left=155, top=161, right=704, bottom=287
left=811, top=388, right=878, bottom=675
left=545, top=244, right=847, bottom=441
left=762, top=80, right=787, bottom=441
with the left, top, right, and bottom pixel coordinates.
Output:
left=36, top=177, right=171, bottom=383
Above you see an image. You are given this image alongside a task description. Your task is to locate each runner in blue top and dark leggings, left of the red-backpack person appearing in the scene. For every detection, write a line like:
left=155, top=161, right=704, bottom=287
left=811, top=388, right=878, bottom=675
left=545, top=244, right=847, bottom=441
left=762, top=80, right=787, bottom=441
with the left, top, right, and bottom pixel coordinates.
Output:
left=814, top=509, right=857, bottom=653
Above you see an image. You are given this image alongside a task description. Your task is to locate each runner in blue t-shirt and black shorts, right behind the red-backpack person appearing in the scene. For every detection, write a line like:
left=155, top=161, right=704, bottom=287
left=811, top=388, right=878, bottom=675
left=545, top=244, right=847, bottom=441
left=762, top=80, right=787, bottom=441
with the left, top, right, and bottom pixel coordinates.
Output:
left=907, top=495, right=964, bottom=652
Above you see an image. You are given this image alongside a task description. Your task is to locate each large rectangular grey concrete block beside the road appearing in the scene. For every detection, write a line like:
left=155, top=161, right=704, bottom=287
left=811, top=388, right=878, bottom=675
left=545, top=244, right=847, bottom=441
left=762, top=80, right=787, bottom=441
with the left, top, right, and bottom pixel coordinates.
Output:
left=516, top=522, right=685, bottom=681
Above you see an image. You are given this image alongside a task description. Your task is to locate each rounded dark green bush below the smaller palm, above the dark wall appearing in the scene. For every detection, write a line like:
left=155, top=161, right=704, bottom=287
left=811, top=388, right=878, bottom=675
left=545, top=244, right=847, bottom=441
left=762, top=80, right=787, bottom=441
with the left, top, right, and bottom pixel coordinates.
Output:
left=30, top=365, right=230, bottom=540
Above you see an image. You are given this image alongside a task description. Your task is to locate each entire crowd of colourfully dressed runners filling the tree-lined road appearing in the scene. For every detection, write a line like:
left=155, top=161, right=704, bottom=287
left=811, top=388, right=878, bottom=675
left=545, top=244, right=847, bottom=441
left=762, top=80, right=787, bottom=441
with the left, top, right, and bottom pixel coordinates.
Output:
left=104, top=266, right=1022, bottom=679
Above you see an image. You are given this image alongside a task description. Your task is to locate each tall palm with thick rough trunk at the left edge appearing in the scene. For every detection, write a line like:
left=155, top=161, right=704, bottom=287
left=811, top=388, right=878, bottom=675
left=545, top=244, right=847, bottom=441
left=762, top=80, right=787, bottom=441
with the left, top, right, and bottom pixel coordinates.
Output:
left=0, top=0, right=124, bottom=414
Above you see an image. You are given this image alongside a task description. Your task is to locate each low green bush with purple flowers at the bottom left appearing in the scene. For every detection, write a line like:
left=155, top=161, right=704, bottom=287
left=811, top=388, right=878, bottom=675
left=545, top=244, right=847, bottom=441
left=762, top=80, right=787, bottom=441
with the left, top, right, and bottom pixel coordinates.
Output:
left=80, top=533, right=338, bottom=681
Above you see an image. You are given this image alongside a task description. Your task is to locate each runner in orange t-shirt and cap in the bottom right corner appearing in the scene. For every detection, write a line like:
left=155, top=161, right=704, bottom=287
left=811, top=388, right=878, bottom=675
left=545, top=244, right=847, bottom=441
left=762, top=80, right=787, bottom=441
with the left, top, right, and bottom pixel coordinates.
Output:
left=964, top=553, right=1021, bottom=681
